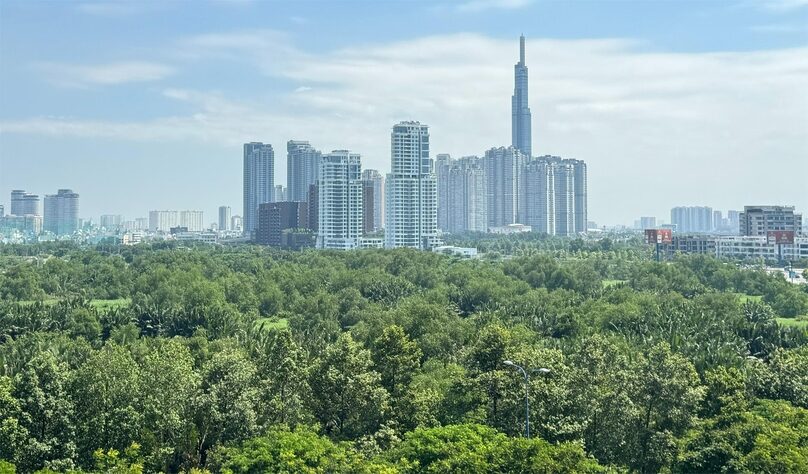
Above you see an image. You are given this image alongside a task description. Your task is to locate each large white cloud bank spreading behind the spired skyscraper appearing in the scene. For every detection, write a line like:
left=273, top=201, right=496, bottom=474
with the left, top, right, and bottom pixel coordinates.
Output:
left=0, top=31, right=808, bottom=223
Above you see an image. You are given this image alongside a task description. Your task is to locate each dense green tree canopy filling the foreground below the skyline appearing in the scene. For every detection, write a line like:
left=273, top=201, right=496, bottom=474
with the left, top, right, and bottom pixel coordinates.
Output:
left=0, top=243, right=808, bottom=473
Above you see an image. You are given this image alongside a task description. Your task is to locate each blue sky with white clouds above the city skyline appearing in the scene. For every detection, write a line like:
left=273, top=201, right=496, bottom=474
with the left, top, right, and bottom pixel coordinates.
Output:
left=0, top=0, right=808, bottom=225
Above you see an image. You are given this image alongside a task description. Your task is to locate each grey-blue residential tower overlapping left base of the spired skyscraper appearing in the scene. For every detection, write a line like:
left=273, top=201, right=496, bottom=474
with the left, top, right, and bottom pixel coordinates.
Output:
left=483, top=146, right=527, bottom=227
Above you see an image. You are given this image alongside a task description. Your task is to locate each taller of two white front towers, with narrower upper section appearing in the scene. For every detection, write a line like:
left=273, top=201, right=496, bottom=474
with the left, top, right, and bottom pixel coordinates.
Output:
left=385, top=122, right=440, bottom=250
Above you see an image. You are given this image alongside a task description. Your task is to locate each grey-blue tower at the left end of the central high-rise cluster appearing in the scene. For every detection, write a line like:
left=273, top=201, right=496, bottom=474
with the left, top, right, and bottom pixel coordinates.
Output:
left=243, top=142, right=275, bottom=233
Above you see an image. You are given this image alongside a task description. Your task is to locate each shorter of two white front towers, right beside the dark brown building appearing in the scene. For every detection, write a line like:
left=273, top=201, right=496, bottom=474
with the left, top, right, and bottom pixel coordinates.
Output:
left=317, top=150, right=362, bottom=250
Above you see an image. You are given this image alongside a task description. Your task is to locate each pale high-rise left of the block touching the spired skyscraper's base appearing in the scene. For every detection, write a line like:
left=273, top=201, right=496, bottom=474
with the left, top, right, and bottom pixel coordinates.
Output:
left=442, top=156, right=488, bottom=233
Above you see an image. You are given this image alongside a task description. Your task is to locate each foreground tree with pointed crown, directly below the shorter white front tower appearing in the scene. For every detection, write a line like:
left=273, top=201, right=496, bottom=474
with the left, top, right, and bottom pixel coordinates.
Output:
left=310, top=333, right=388, bottom=439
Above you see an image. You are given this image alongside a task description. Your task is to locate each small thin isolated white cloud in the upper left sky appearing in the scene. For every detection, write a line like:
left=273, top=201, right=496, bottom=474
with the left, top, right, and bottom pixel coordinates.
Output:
left=34, top=61, right=175, bottom=87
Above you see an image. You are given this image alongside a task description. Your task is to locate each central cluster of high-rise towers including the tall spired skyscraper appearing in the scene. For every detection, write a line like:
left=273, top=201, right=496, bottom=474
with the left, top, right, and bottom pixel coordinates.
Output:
left=240, top=37, right=587, bottom=249
